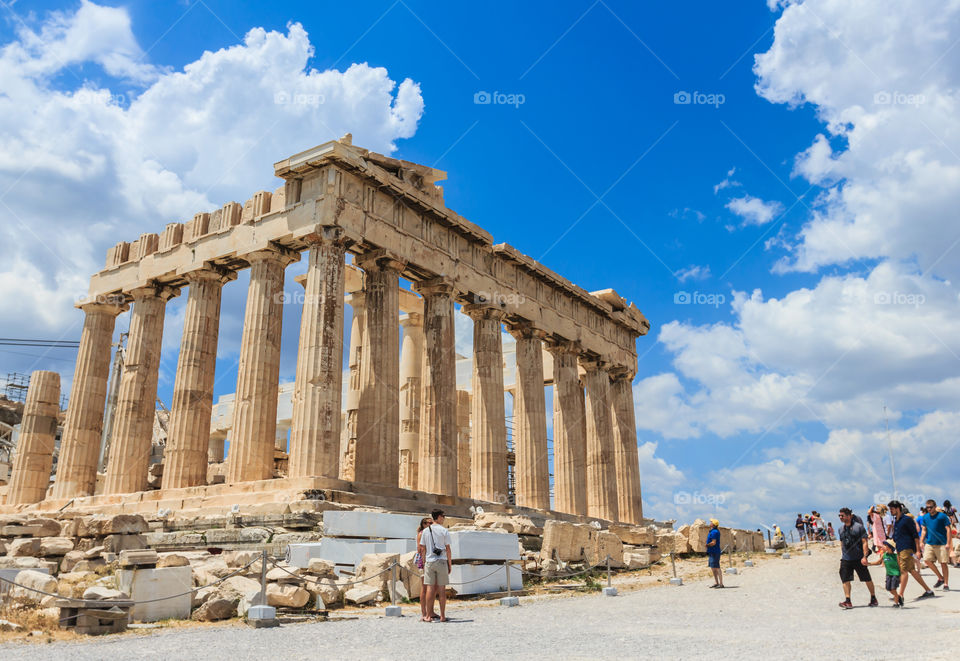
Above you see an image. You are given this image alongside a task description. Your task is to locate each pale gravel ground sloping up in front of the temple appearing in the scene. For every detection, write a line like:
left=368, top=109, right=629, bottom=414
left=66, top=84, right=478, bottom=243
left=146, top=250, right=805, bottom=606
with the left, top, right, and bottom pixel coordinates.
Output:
left=0, top=548, right=960, bottom=661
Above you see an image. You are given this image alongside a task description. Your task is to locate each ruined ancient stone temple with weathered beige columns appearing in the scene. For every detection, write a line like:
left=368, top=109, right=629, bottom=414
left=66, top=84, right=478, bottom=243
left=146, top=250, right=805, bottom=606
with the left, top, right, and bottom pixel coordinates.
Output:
left=6, top=136, right=649, bottom=523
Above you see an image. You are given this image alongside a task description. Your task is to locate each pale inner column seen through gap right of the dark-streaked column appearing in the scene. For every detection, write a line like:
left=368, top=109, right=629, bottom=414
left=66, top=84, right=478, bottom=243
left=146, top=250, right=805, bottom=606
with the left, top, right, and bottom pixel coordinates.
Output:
left=400, top=312, right=423, bottom=489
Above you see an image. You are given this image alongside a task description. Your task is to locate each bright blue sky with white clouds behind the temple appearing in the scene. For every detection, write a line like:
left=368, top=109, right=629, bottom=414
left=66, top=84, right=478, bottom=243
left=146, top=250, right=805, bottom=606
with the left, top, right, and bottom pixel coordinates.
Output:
left=0, top=0, right=960, bottom=527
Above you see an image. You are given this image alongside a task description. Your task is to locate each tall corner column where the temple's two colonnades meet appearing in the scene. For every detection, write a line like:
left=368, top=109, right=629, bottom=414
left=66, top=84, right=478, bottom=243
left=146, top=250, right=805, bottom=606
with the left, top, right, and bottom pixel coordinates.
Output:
left=289, top=227, right=345, bottom=478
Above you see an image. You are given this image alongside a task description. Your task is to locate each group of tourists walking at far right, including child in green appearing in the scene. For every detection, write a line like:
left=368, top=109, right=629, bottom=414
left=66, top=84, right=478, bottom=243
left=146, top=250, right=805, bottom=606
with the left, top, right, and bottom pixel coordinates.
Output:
left=839, top=500, right=960, bottom=609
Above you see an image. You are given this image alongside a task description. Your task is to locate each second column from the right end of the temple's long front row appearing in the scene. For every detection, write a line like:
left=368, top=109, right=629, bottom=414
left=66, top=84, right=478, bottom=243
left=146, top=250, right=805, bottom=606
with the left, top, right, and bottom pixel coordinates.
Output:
left=580, top=357, right=619, bottom=521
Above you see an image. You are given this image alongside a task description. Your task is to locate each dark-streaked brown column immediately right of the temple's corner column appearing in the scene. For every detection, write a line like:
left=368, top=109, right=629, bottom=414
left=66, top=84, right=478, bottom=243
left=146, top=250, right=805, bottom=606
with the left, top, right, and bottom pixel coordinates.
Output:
left=354, top=250, right=404, bottom=487
